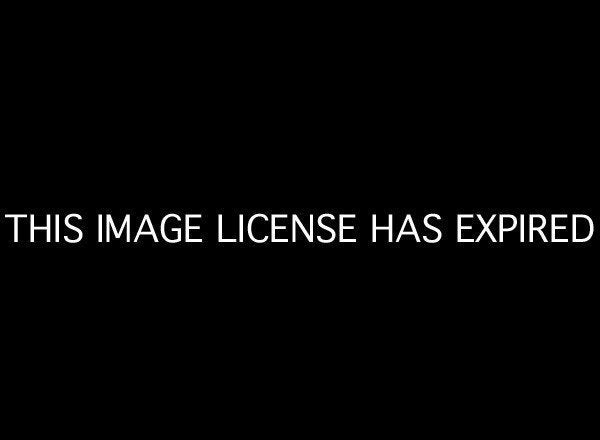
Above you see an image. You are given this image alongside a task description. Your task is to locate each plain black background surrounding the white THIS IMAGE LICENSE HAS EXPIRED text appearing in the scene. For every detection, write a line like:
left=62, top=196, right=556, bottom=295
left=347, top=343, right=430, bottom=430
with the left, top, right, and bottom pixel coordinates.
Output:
left=1, top=5, right=598, bottom=433
